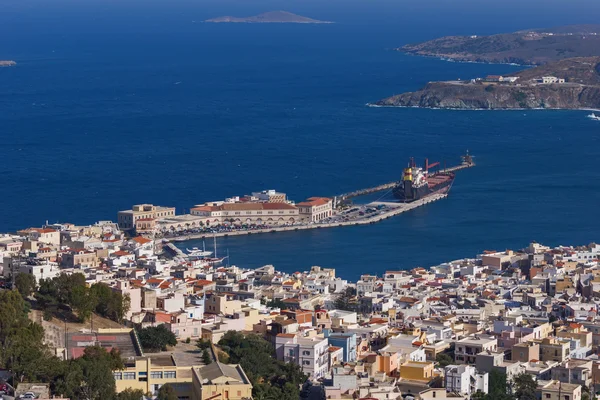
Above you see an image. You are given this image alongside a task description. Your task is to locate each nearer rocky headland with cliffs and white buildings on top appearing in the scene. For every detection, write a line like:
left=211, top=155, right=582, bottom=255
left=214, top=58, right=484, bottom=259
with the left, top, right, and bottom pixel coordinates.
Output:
left=373, top=57, right=600, bottom=109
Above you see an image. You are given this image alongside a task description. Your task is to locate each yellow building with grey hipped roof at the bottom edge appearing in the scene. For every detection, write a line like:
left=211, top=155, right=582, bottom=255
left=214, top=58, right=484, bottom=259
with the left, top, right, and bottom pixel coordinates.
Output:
left=191, top=361, right=252, bottom=400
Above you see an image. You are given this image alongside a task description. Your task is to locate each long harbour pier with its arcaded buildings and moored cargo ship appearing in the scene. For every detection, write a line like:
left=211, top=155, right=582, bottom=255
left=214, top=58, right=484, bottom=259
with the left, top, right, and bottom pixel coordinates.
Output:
left=134, top=152, right=475, bottom=243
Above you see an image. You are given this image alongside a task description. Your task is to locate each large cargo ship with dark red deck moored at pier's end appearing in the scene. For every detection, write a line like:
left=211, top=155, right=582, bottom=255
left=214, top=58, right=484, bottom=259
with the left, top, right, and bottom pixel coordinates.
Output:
left=392, top=158, right=455, bottom=202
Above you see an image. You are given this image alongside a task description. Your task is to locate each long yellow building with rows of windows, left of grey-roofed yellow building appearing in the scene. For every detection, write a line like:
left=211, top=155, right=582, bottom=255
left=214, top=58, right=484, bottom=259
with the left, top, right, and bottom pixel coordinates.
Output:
left=113, top=355, right=192, bottom=397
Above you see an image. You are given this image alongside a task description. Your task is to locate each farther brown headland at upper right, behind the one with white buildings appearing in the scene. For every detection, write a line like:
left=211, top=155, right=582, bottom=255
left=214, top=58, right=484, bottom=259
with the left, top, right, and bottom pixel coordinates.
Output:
left=396, top=25, right=600, bottom=65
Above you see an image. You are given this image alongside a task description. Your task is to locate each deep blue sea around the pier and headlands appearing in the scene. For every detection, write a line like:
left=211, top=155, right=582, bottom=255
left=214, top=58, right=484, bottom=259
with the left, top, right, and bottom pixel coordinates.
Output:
left=0, top=0, right=600, bottom=280
